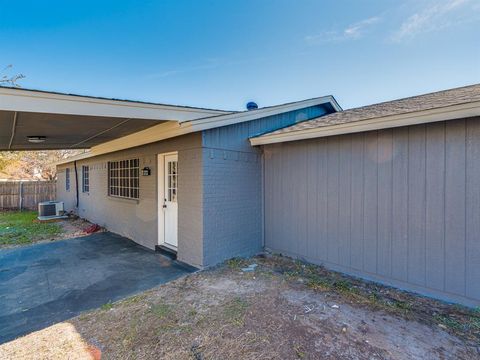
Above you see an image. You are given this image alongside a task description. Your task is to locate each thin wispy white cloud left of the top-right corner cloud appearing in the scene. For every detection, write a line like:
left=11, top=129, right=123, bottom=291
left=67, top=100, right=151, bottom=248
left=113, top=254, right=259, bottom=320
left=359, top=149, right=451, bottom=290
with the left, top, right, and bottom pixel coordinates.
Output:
left=305, top=16, right=380, bottom=44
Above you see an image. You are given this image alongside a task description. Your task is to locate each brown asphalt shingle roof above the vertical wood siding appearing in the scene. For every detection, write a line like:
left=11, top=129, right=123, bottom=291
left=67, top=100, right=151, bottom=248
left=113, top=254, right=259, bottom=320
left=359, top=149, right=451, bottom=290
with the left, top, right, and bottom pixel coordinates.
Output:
left=260, top=84, right=480, bottom=137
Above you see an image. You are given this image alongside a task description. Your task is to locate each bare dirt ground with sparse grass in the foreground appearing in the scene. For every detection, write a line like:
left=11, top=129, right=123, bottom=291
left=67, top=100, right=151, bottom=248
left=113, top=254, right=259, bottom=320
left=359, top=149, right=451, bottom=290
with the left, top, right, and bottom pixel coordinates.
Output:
left=0, top=256, right=480, bottom=360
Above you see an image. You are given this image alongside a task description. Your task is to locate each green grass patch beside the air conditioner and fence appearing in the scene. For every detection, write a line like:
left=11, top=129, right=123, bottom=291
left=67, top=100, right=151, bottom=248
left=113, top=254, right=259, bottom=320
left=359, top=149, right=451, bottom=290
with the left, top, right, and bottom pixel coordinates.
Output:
left=0, top=211, right=62, bottom=246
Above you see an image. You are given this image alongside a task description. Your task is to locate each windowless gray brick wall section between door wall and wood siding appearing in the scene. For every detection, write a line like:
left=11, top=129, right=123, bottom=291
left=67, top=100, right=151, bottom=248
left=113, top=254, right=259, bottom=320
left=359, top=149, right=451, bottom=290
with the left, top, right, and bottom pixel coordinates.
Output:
left=203, top=148, right=262, bottom=265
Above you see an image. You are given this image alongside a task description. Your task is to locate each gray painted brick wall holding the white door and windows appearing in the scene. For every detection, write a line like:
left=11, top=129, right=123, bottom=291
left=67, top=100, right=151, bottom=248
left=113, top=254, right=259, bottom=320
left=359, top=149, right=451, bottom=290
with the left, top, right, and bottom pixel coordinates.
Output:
left=57, top=133, right=203, bottom=266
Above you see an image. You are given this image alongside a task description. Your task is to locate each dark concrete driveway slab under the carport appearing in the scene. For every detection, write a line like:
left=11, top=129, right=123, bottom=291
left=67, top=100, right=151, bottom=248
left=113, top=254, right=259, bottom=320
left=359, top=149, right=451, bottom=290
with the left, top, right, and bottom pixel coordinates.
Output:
left=0, top=233, right=193, bottom=343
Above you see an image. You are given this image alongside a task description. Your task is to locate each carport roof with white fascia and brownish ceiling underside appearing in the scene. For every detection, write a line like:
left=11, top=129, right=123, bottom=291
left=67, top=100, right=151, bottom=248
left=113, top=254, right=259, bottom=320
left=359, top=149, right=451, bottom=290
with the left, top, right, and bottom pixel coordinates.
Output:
left=0, top=87, right=229, bottom=150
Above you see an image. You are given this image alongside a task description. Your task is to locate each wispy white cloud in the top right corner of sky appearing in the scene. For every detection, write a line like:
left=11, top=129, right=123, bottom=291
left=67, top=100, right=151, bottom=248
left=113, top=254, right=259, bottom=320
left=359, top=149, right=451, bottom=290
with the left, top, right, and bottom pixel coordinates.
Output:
left=392, top=0, right=478, bottom=41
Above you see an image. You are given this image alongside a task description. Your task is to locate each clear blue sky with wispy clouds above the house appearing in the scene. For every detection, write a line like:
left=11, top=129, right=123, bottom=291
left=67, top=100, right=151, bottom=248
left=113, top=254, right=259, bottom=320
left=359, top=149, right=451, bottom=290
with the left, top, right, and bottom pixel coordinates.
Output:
left=0, top=0, right=480, bottom=110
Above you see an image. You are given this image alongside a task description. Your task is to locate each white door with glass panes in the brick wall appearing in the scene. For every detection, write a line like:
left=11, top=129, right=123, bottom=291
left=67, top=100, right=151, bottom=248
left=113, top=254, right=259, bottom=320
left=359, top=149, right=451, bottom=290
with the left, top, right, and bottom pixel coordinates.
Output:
left=158, top=154, right=178, bottom=248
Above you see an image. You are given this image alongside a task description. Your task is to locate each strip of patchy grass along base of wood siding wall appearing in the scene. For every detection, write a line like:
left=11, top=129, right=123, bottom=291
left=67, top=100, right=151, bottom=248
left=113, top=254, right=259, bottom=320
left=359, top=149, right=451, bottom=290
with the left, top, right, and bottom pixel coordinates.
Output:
left=261, top=256, right=480, bottom=341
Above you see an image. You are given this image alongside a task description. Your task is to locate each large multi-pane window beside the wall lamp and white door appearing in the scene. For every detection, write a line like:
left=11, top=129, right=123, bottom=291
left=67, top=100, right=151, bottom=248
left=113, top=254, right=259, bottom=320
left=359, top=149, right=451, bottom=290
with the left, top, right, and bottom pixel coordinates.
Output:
left=108, top=159, right=140, bottom=199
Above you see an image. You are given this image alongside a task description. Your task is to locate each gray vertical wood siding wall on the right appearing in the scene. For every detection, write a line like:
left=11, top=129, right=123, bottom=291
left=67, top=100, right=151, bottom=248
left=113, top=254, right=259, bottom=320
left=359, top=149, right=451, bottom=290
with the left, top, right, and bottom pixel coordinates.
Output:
left=265, top=118, right=480, bottom=305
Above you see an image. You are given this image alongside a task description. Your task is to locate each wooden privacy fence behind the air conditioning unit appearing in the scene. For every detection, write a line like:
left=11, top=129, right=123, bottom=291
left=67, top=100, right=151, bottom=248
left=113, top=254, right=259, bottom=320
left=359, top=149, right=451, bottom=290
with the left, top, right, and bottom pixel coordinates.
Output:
left=0, top=181, right=56, bottom=210
